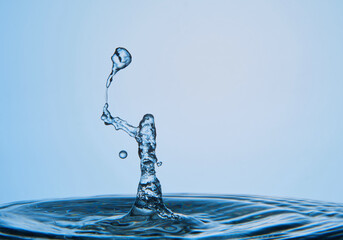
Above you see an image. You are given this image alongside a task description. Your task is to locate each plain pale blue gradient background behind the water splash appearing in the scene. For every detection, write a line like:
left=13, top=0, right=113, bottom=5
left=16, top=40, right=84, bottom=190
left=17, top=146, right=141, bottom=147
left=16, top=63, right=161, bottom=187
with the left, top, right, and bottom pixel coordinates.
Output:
left=0, top=0, right=343, bottom=202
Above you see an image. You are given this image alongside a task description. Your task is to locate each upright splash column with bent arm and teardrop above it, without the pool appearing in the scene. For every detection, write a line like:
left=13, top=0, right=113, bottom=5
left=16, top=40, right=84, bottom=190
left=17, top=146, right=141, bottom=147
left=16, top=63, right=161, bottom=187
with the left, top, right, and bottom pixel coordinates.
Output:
left=101, top=48, right=177, bottom=220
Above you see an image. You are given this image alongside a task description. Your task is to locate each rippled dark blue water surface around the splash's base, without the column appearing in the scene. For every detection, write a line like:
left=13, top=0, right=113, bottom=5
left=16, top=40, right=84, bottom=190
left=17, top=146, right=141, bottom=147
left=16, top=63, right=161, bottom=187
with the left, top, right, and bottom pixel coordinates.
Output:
left=0, top=195, right=343, bottom=239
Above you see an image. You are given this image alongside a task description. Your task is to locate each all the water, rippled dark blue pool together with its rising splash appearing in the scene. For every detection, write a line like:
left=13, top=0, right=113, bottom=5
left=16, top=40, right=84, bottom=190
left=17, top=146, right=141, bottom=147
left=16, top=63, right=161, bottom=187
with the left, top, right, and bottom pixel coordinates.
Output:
left=0, top=48, right=343, bottom=240
